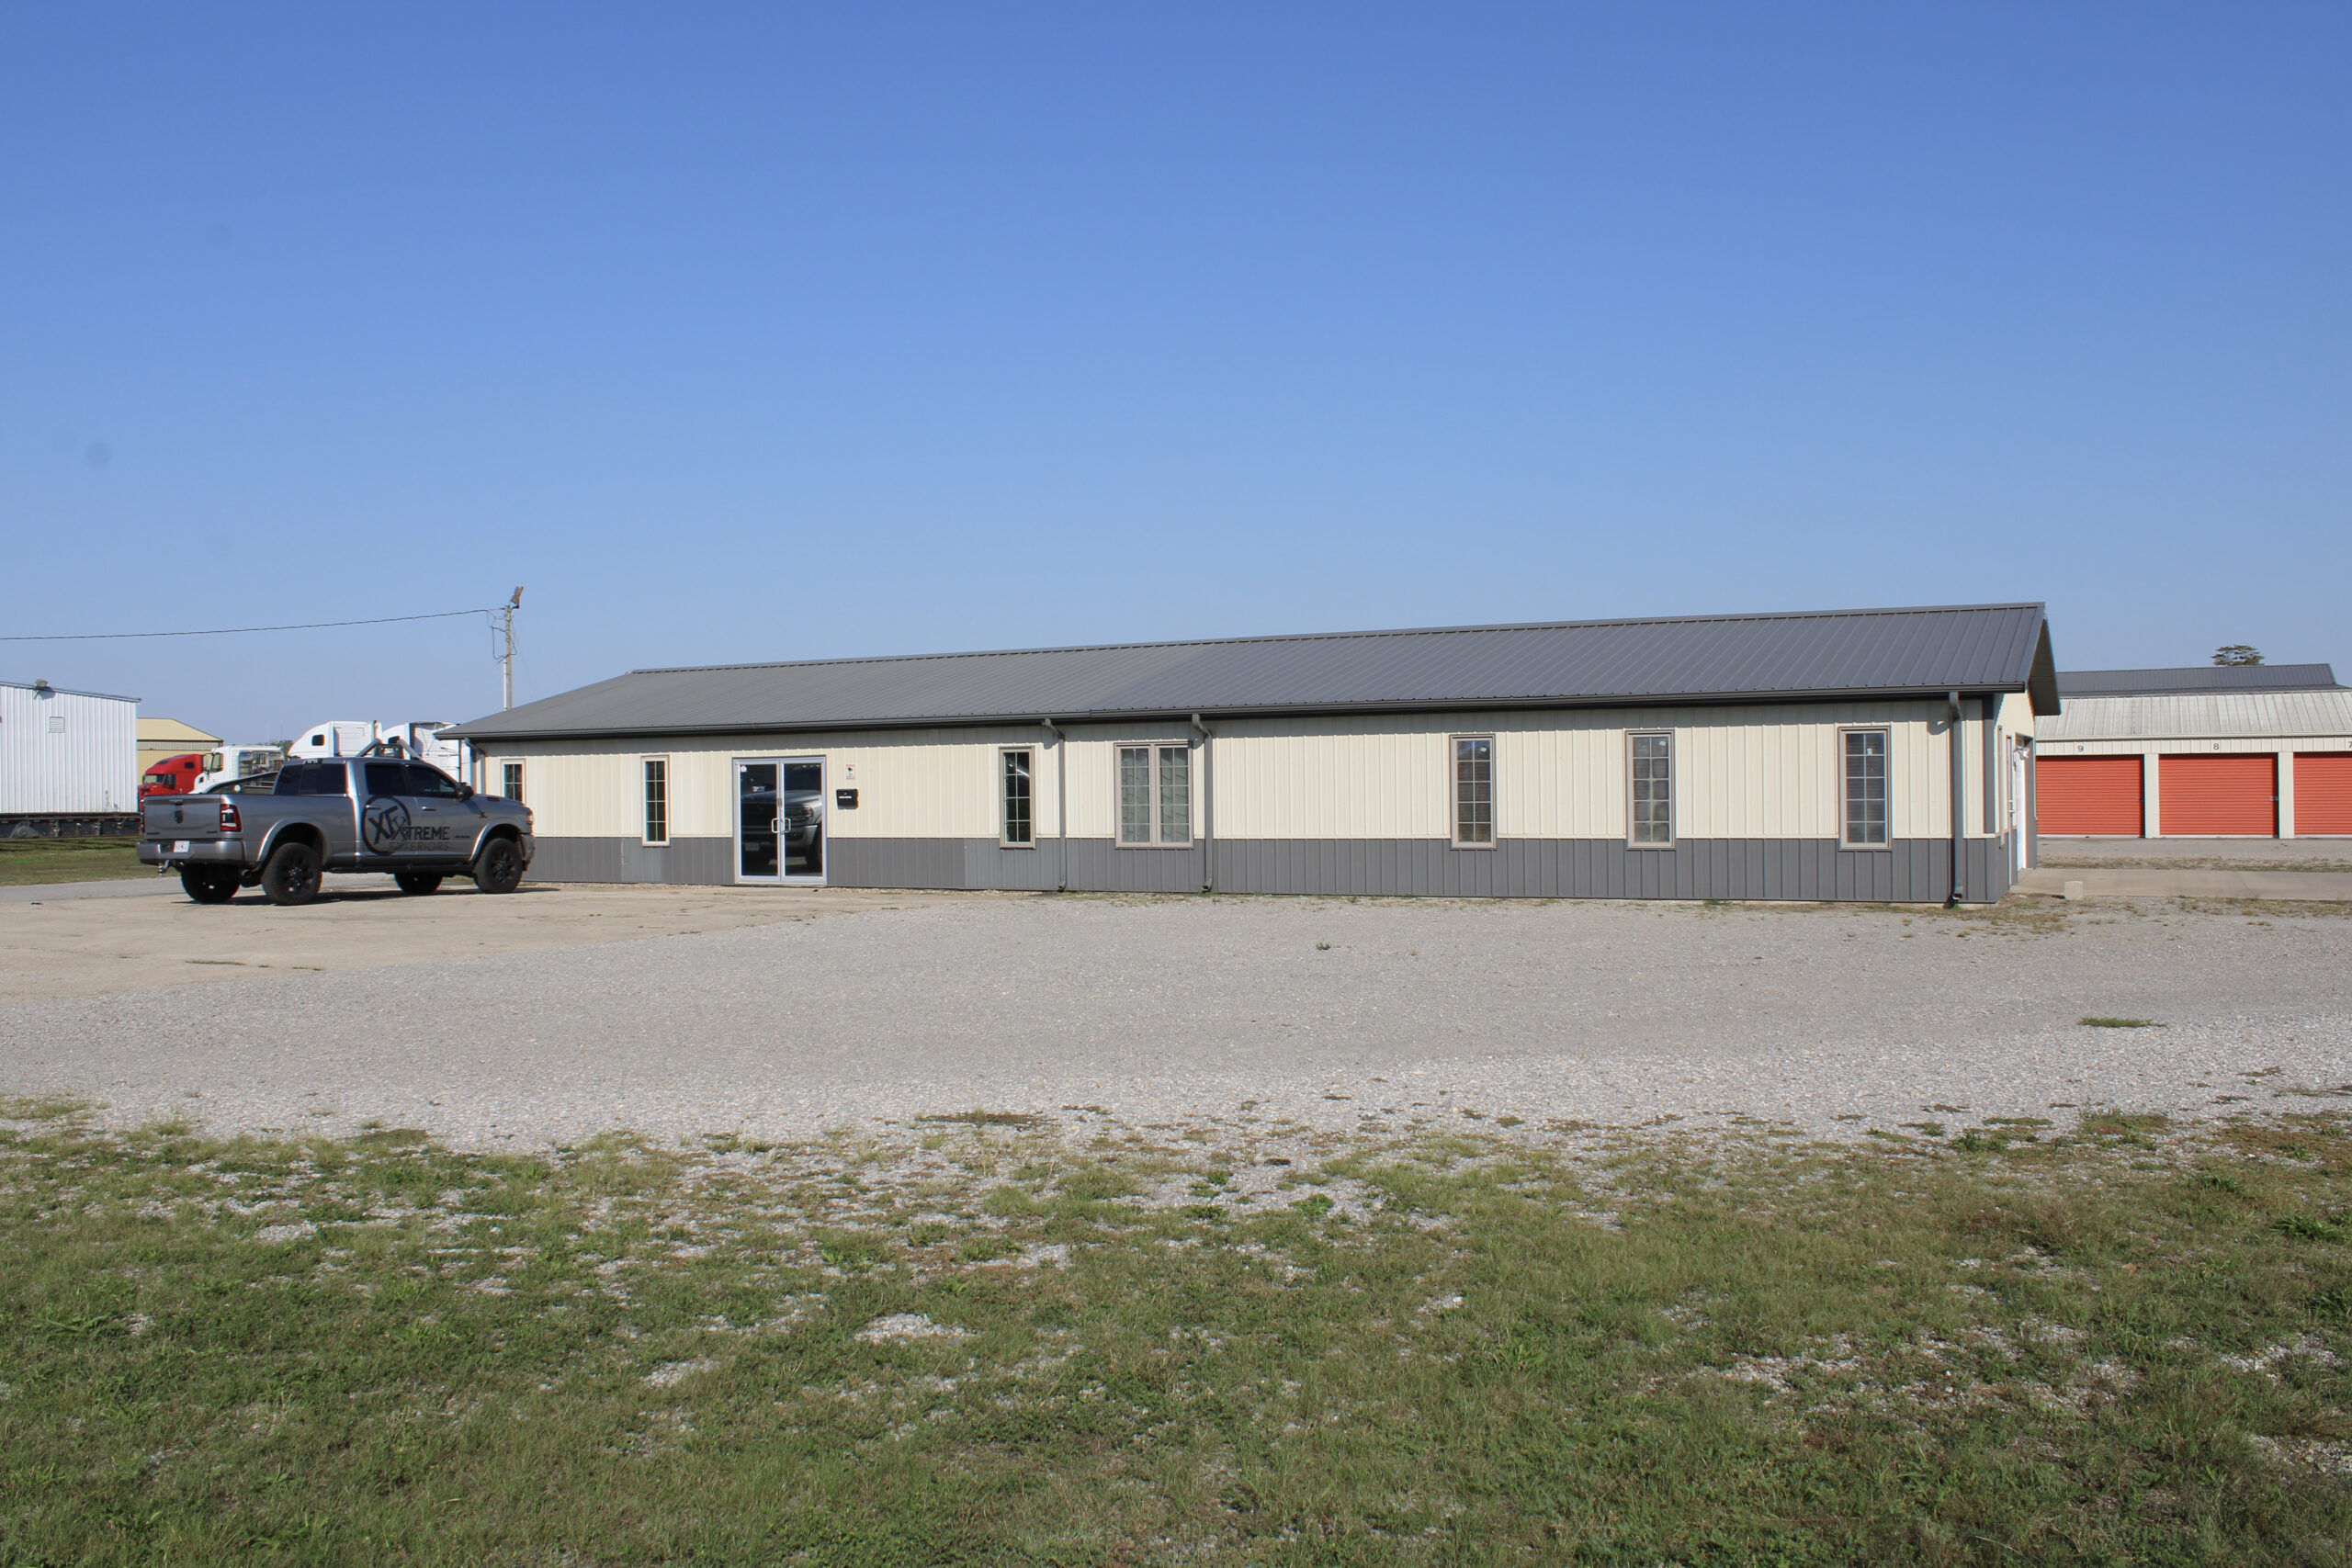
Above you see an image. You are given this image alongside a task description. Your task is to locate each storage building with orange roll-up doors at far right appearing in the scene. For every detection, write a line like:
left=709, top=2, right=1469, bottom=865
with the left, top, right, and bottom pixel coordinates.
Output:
left=2034, top=665, right=2352, bottom=840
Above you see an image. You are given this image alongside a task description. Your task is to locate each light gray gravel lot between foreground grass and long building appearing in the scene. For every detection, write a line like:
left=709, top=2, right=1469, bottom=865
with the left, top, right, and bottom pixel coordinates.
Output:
left=0, top=898, right=2352, bottom=1147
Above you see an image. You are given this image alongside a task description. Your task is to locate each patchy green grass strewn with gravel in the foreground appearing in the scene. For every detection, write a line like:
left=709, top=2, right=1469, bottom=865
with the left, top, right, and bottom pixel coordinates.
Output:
left=0, top=1105, right=2352, bottom=1568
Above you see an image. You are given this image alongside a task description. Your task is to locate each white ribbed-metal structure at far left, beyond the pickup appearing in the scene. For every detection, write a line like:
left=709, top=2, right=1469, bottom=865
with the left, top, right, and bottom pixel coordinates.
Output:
left=0, top=682, right=139, bottom=837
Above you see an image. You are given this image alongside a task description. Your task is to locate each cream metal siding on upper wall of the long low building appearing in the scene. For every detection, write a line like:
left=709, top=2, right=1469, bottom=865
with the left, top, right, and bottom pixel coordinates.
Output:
left=484, top=701, right=2007, bottom=864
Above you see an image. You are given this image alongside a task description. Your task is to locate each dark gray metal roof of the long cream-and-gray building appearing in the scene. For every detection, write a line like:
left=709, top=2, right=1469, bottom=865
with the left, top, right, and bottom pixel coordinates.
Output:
left=454, top=604, right=2058, bottom=740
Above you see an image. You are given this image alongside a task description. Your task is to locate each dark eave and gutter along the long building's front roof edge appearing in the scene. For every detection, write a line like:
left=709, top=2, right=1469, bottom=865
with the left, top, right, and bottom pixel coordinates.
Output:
left=442, top=682, right=2055, bottom=745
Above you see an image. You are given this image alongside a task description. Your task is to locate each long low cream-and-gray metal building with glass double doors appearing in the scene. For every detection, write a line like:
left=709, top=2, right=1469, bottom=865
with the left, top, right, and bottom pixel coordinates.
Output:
left=442, top=604, right=2058, bottom=900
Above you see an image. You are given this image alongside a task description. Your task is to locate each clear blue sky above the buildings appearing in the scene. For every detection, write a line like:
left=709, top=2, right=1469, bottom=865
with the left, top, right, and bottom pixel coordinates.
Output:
left=0, top=5, right=2352, bottom=739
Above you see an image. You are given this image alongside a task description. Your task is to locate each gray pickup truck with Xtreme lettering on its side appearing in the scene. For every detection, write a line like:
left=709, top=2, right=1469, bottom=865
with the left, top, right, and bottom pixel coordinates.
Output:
left=139, top=757, right=534, bottom=903
